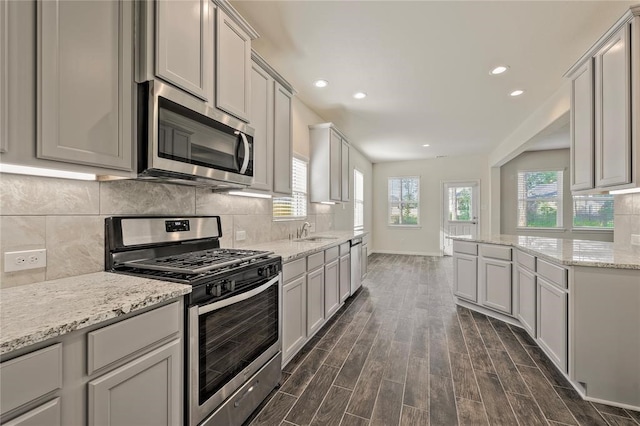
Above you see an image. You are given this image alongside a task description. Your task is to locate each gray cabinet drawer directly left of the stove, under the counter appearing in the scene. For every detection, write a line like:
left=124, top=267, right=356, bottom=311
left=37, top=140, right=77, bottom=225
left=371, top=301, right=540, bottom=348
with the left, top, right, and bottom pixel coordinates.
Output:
left=87, top=302, right=180, bottom=374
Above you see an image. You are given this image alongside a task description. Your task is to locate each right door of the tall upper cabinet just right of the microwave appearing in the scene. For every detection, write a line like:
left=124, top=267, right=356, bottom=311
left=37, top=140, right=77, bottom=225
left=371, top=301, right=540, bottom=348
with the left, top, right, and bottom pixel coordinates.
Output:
left=273, top=82, right=293, bottom=195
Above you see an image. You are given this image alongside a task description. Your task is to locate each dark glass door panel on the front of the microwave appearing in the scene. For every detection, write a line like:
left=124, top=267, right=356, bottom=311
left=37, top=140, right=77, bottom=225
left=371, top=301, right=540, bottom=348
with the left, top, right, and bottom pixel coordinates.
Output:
left=158, top=98, right=253, bottom=175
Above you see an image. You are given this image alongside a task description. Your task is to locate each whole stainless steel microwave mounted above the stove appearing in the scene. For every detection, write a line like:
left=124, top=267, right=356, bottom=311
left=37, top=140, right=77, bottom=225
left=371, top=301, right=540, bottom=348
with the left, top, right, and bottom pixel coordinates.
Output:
left=138, top=81, right=254, bottom=189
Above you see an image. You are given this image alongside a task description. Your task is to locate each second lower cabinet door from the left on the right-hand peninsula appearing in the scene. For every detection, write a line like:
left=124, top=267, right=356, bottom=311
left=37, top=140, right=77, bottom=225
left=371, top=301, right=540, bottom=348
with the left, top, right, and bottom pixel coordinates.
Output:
left=479, top=258, right=512, bottom=314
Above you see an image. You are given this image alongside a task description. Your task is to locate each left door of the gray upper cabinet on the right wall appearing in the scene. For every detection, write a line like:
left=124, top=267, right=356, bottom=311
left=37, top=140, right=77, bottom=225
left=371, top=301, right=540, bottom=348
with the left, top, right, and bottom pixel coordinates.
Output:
left=571, top=61, right=595, bottom=191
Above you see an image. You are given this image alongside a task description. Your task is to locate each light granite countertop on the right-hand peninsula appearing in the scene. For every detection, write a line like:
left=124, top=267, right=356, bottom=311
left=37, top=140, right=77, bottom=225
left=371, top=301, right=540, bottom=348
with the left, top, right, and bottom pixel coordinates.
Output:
left=449, top=235, right=640, bottom=270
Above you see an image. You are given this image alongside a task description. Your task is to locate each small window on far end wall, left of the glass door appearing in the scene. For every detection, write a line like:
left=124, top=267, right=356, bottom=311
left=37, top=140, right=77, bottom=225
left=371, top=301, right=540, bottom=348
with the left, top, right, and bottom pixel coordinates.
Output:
left=389, top=176, right=420, bottom=225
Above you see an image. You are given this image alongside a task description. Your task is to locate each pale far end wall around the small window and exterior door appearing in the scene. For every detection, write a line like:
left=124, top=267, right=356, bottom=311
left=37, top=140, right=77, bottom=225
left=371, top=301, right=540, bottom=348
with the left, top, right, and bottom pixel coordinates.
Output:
left=372, top=155, right=490, bottom=256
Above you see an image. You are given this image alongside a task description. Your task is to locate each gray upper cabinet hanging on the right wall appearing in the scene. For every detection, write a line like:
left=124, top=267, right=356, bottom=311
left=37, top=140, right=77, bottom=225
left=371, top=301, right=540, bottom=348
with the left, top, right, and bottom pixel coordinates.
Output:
left=565, top=6, right=640, bottom=192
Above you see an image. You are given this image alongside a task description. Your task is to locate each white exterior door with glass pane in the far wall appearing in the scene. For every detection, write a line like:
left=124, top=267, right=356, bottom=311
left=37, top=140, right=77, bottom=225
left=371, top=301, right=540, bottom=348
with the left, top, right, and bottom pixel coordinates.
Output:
left=442, top=181, right=480, bottom=256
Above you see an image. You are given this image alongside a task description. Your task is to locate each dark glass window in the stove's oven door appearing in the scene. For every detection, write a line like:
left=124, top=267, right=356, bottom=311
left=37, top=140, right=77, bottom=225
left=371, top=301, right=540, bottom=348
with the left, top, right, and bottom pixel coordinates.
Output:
left=198, top=284, right=278, bottom=404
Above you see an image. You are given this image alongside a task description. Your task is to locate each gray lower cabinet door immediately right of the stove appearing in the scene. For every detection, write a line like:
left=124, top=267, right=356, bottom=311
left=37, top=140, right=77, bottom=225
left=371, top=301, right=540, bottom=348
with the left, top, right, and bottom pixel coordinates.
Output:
left=282, top=275, right=307, bottom=361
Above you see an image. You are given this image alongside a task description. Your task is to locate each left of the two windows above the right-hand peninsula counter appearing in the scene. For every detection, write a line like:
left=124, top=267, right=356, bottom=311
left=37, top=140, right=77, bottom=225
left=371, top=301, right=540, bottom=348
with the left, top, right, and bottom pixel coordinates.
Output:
left=518, top=171, right=562, bottom=228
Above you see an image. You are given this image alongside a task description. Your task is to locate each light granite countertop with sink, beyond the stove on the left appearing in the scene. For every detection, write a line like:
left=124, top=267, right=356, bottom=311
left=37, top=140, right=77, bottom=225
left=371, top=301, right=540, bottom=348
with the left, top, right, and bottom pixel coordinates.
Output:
left=243, top=231, right=368, bottom=263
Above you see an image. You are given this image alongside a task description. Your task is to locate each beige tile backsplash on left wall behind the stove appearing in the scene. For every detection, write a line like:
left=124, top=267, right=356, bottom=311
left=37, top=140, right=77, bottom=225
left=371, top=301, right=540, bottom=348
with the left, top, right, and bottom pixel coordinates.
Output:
left=0, top=174, right=334, bottom=287
